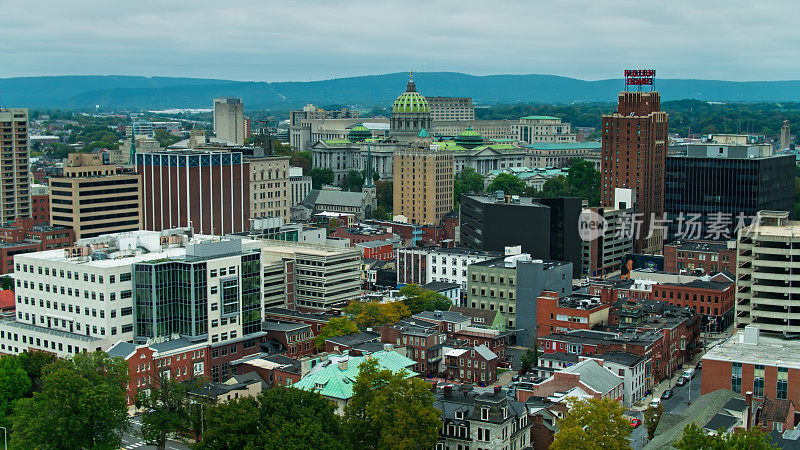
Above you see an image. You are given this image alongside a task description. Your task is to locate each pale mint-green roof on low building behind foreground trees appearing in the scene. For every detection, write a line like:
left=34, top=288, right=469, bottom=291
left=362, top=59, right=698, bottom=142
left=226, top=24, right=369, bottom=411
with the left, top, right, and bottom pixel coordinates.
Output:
left=292, top=350, right=418, bottom=400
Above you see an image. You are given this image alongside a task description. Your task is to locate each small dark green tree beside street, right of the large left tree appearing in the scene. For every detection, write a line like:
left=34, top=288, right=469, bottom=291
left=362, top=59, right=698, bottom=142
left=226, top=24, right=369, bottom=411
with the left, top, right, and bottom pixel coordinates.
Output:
left=136, top=369, right=196, bottom=450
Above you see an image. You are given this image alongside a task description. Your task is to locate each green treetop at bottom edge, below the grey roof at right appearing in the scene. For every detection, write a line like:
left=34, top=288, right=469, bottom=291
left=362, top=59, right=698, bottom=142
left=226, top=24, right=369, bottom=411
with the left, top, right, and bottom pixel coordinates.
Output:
left=672, top=422, right=777, bottom=450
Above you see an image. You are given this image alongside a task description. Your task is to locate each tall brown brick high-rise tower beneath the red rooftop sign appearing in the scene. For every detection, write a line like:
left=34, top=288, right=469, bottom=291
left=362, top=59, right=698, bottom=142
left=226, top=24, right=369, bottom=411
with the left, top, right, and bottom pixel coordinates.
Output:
left=601, top=85, right=668, bottom=254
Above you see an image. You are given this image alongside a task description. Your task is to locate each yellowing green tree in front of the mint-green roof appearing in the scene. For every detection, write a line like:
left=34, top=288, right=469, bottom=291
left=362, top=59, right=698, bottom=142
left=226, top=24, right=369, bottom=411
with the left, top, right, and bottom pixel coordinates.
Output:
left=344, top=359, right=442, bottom=449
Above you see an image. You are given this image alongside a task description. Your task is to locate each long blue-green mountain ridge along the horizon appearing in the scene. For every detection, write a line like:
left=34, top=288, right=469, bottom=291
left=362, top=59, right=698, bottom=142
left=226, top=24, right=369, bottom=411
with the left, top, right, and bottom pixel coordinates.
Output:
left=0, top=72, right=800, bottom=110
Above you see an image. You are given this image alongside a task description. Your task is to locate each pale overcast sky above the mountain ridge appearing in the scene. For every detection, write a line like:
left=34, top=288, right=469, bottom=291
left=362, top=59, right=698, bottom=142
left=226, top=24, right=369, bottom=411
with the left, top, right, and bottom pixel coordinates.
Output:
left=0, top=0, right=800, bottom=81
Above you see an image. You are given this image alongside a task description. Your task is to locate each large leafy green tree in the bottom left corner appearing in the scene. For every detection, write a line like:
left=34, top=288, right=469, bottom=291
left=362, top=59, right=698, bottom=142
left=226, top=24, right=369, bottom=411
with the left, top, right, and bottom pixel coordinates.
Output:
left=11, top=351, right=129, bottom=449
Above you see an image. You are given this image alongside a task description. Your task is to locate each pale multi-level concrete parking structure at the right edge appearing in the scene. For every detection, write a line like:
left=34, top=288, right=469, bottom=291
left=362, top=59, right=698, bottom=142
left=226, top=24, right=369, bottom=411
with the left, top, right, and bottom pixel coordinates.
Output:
left=736, top=211, right=800, bottom=336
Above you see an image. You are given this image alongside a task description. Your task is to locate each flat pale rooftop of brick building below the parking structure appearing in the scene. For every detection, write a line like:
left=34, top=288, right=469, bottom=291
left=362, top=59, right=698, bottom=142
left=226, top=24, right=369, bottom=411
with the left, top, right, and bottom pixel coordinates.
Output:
left=703, top=331, right=800, bottom=369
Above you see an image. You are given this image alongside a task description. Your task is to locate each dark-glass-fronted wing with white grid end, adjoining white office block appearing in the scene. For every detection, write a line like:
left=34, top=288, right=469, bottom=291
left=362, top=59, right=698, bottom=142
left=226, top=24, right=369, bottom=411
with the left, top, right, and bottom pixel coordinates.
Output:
left=132, top=238, right=263, bottom=346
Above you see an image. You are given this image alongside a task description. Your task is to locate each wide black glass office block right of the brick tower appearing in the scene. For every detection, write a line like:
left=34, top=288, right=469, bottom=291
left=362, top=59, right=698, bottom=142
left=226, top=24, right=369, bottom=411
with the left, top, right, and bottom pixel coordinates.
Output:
left=664, top=143, right=796, bottom=241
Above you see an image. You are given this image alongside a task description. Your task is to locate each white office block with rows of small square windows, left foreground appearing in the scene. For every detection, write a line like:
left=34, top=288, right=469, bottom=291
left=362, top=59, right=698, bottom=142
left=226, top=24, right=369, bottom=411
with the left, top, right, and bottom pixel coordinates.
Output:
left=0, top=228, right=244, bottom=357
